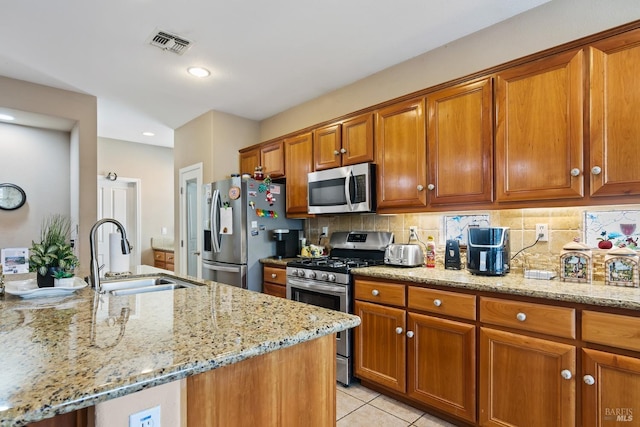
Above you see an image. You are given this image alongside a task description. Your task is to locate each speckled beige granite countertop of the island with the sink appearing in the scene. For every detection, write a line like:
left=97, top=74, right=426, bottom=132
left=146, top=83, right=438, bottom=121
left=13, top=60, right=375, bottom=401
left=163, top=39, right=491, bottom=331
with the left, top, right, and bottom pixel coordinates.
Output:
left=0, top=268, right=360, bottom=426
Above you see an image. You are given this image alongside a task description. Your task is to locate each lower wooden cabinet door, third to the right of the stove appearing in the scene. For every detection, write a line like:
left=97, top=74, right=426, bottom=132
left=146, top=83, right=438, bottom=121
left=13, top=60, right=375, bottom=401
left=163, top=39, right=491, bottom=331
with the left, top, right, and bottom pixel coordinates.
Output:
left=480, top=328, right=576, bottom=427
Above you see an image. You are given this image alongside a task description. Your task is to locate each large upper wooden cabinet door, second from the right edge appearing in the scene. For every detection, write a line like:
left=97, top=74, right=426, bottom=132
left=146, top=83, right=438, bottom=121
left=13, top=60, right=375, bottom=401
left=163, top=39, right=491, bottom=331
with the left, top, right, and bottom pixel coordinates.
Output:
left=496, top=51, right=583, bottom=202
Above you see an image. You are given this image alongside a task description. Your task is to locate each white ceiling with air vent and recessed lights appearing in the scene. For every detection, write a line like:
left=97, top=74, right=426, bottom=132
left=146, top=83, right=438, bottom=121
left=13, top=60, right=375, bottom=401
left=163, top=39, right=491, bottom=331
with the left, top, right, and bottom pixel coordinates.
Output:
left=0, top=0, right=549, bottom=147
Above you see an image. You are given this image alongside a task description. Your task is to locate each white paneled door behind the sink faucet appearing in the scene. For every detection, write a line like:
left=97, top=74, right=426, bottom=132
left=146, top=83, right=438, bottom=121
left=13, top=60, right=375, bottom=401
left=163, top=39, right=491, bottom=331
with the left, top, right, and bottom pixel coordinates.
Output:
left=96, top=176, right=142, bottom=276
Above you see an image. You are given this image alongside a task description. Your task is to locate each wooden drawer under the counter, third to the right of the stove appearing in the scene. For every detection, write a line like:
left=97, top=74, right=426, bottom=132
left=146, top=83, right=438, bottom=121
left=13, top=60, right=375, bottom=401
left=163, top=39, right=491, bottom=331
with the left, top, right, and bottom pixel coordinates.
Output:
left=480, top=298, right=576, bottom=338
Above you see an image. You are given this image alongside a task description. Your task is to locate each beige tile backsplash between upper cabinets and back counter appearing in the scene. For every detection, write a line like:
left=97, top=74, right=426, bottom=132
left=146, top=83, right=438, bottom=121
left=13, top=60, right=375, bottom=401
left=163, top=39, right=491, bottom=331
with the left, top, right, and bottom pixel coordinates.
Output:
left=305, top=205, right=640, bottom=280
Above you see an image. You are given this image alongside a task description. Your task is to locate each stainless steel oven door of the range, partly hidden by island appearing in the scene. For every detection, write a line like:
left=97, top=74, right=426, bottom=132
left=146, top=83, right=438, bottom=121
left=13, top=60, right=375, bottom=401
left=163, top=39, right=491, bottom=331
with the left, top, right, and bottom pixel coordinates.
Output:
left=287, top=277, right=351, bottom=357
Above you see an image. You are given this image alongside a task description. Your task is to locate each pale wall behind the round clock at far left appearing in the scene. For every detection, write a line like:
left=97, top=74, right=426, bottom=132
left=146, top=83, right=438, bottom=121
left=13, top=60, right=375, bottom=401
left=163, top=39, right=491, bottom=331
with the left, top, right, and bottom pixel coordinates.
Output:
left=0, top=123, right=71, bottom=248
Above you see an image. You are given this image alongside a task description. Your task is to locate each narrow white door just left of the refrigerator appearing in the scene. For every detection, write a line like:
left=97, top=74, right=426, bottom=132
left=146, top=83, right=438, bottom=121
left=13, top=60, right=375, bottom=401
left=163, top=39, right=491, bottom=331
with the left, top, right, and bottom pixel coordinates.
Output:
left=180, top=163, right=202, bottom=279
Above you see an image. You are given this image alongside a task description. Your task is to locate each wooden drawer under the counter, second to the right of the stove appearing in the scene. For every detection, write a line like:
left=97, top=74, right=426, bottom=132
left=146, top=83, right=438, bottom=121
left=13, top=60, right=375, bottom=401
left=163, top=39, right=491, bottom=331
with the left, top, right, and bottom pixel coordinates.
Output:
left=408, top=286, right=476, bottom=320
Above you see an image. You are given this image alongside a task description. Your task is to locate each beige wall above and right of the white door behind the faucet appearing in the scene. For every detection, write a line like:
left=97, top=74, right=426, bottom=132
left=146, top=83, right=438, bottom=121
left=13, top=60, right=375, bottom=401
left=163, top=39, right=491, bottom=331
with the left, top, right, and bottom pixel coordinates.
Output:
left=98, top=138, right=174, bottom=265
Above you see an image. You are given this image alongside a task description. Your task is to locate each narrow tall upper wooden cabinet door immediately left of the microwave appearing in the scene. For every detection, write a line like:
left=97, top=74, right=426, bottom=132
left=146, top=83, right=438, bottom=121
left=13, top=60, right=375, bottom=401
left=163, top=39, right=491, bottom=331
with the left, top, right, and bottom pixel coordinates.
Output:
left=284, top=133, right=313, bottom=217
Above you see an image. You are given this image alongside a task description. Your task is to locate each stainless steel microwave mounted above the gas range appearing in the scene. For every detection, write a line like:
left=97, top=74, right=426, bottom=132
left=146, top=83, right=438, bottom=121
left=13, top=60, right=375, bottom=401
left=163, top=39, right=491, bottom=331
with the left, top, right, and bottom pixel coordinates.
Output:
left=307, top=163, right=376, bottom=214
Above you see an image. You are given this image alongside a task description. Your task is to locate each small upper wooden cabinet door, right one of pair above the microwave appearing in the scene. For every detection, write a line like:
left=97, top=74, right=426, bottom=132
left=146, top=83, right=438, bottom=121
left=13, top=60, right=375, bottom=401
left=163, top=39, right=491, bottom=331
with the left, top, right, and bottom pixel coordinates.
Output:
left=340, top=113, right=374, bottom=166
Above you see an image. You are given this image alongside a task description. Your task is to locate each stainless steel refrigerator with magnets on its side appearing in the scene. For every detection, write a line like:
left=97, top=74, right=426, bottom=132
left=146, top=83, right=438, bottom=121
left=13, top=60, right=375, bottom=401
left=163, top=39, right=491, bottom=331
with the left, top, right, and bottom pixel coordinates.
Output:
left=202, top=177, right=303, bottom=292
